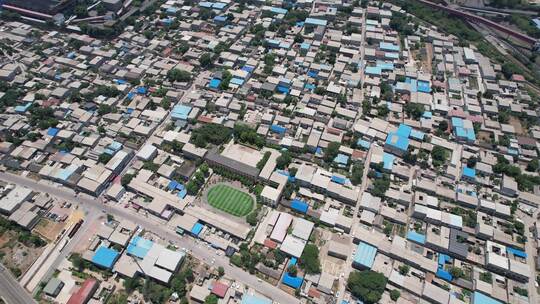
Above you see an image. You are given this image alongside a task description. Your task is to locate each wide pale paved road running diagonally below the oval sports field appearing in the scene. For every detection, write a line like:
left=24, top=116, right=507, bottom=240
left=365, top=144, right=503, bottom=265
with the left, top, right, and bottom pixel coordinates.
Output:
left=0, top=173, right=300, bottom=304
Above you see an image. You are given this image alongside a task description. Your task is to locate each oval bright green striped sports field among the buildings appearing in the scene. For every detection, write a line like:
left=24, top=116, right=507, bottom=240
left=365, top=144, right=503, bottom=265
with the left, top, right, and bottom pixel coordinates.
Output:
left=208, top=185, right=253, bottom=216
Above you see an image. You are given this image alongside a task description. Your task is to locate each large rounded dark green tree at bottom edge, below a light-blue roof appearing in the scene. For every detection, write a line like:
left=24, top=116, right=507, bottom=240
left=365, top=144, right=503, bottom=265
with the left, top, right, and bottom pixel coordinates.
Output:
left=347, top=270, right=387, bottom=304
